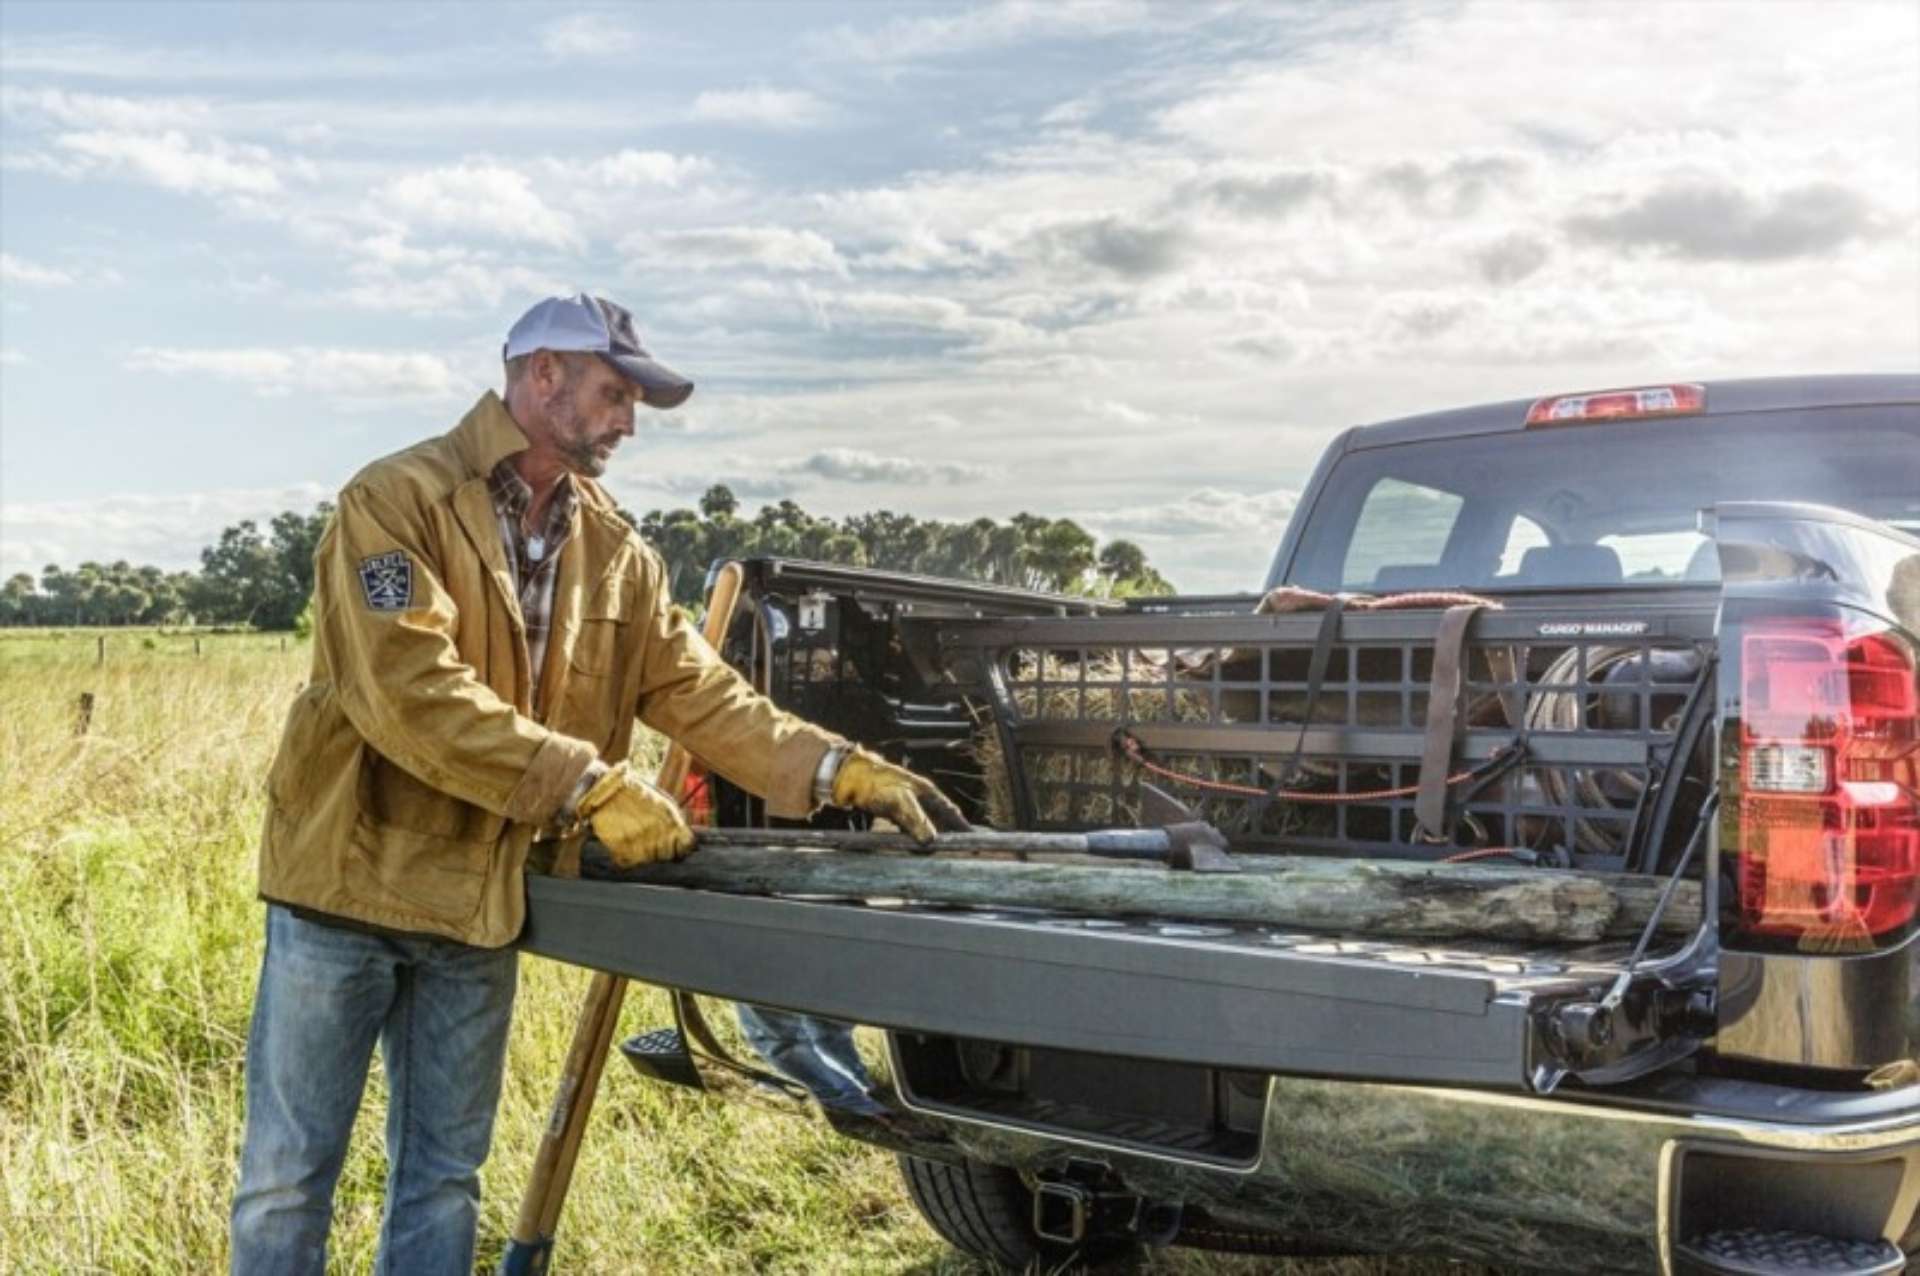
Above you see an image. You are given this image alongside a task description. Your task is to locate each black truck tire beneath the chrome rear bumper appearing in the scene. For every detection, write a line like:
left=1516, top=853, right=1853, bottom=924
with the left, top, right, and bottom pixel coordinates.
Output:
left=899, top=1153, right=1139, bottom=1272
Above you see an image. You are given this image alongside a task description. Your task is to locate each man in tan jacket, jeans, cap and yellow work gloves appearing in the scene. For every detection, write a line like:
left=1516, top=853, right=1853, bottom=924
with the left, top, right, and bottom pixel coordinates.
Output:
left=232, top=294, right=966, bottom=1276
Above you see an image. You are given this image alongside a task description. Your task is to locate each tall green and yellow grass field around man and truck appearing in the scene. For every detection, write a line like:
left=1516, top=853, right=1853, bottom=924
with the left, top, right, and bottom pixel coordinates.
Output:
left=0, top=629, right=1482, bottom=1276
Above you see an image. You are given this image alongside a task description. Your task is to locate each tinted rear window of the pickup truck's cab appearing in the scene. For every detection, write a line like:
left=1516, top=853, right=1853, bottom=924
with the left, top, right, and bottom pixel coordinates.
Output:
left=1286, top=405, right=1920, bottom=593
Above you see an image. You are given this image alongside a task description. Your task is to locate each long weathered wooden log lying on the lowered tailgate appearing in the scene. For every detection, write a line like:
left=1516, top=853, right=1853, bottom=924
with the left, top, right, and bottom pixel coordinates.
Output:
left=595, top=846, right=1701, bottom=944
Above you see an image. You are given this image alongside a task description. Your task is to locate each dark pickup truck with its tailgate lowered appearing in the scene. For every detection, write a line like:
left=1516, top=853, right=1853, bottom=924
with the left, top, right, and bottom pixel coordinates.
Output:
left=526, top=376, right=1920, bottom=1274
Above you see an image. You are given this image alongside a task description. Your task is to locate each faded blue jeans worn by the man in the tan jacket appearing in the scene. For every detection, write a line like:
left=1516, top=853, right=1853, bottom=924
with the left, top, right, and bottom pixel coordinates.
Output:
left=232, top=904, right=518, bottom=1276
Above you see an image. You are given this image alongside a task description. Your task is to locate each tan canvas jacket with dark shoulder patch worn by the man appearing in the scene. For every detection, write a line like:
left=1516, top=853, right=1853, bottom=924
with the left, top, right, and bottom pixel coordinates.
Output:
left=259, top=391, right=835, bottom=948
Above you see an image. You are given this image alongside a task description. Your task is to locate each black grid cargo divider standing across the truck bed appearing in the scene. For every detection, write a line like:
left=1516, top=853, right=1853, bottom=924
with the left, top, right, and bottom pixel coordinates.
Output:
left=977, top=637, right=1705, bottom=867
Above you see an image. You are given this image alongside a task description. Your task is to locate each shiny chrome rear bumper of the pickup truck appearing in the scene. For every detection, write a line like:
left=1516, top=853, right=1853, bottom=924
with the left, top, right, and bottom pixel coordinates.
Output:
left=883, top=1076, right=1920, bottom=1274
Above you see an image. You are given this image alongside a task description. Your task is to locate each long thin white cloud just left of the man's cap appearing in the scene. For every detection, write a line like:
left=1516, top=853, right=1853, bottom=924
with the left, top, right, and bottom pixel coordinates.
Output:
left=127, top=345, right=457, bottom=401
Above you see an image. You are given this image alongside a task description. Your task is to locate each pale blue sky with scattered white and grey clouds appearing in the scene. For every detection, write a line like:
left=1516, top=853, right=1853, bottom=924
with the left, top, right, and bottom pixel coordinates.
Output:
left=0, top=0, right=1920, bottom=589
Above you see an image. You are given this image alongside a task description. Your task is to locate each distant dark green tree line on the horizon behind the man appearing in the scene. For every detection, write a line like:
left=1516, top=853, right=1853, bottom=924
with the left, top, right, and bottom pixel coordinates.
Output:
left=0, top=484, right=1173, bottom=629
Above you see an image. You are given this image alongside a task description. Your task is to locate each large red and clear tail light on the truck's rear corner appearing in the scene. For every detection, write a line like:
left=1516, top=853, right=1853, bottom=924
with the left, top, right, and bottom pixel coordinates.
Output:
left=1734, top=614, right=1920, bottom=952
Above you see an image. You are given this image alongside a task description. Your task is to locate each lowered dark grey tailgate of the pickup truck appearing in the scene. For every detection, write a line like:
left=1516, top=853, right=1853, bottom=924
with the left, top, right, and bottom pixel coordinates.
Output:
left=520, top=877, right=1617, bottom=1088
